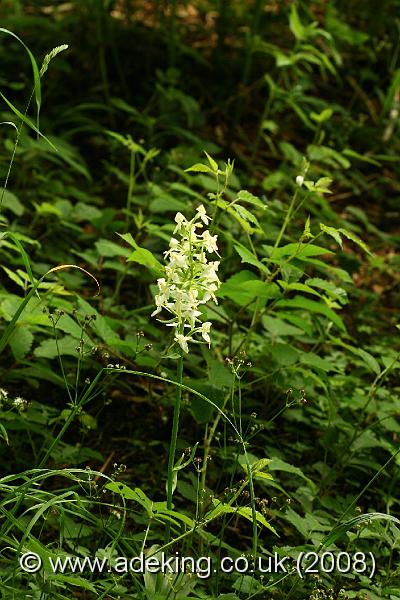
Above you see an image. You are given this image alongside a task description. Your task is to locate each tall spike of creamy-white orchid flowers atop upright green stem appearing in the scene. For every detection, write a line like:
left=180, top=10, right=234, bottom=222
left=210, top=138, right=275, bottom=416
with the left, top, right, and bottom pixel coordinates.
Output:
left=152, top=204, right=220, bottom=353
